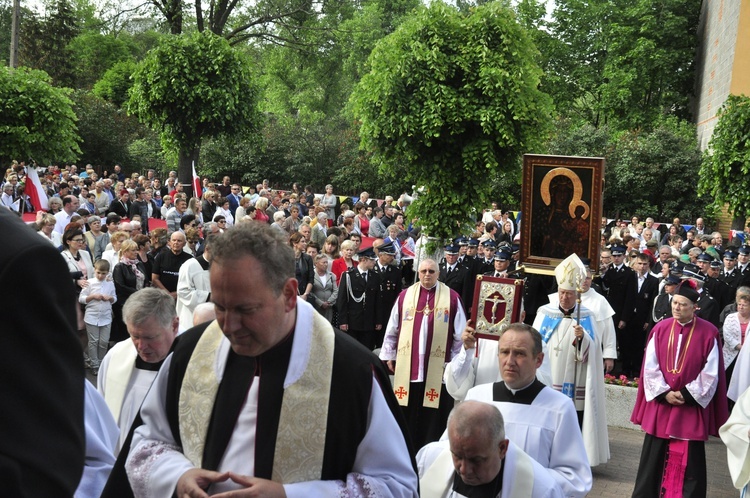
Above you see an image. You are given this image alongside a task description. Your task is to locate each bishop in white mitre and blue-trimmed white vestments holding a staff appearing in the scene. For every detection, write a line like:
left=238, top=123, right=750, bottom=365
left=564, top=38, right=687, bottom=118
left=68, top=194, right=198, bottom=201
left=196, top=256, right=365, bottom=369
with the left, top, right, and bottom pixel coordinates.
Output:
left=533, top=254, right=609, bottom=467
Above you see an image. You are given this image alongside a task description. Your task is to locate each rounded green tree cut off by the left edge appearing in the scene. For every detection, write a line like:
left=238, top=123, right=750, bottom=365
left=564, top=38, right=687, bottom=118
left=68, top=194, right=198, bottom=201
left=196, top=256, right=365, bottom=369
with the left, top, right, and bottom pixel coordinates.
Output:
left=0, top=67, right=81, bottom=163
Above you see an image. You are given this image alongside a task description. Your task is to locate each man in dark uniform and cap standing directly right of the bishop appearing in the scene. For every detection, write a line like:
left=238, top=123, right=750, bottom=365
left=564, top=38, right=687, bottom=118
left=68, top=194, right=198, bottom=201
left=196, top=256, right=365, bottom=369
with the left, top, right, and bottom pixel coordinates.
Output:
left=594, top=245, right=638, bottom=364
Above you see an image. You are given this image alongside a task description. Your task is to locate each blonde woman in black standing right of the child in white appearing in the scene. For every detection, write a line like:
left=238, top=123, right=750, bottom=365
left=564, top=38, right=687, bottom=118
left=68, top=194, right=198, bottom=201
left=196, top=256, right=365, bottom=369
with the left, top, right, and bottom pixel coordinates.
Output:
left=110, top=236, right=150, bottom=342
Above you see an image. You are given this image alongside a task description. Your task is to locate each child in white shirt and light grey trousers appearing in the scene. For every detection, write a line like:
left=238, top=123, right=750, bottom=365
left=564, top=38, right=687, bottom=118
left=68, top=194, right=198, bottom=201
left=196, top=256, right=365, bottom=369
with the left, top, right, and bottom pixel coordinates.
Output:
left=78, top=259, right=117, bottom=375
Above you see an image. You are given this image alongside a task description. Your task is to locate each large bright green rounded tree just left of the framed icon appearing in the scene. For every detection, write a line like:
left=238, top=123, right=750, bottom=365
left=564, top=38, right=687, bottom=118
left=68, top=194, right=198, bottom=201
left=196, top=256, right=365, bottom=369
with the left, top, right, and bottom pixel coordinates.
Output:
left=351, top=2, right=551, bottom=244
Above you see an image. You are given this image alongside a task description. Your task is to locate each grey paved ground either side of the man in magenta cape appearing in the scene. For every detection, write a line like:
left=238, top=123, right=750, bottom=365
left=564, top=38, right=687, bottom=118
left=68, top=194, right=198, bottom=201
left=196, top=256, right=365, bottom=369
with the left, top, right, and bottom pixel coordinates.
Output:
left=589, top=427, right=739, bottom=498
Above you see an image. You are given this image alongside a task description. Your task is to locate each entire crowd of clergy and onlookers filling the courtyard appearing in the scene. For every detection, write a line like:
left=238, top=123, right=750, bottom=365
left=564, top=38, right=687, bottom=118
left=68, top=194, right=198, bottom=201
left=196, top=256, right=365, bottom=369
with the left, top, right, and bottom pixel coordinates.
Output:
left=7, top=163, right=750, bottom=497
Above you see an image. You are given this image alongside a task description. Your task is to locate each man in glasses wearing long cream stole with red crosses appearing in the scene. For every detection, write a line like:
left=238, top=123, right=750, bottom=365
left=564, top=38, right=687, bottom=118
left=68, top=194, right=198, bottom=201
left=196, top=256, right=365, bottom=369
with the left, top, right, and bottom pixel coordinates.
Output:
left=380, top=259, right=466, bottom=447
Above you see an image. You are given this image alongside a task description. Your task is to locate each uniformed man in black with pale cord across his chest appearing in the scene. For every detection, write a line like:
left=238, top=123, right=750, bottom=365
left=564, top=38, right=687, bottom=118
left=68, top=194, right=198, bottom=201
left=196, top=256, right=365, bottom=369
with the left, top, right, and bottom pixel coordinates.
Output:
left=336, top=247, right=385, bottom=350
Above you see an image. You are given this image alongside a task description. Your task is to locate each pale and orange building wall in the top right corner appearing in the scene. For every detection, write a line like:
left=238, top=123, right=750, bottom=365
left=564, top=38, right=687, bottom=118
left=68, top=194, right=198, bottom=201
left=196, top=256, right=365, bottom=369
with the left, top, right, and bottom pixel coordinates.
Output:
left=694, top=0, right=750, bottom=149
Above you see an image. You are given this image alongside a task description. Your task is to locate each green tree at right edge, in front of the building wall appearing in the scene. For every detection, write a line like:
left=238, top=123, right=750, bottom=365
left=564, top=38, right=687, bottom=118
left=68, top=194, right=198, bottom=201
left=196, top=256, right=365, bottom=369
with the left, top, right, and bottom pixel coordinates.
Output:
left=698, top=95, right=750, bottom=226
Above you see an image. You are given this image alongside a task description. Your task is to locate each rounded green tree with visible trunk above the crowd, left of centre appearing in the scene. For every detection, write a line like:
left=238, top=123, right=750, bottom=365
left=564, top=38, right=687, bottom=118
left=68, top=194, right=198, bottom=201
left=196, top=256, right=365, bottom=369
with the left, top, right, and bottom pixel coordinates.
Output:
left=128, top=29, right=260, bottom=193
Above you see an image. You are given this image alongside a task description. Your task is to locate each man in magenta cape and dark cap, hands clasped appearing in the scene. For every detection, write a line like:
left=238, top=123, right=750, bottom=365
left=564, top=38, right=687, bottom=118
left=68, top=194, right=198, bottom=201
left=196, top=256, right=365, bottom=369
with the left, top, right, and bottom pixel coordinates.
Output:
left=631, top=281, right=727, bottom=498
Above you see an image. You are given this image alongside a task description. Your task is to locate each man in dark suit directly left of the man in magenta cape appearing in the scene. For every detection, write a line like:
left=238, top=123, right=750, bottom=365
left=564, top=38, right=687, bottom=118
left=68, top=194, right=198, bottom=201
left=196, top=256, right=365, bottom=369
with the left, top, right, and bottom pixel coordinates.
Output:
left=620, top=253, right=659, bottom=377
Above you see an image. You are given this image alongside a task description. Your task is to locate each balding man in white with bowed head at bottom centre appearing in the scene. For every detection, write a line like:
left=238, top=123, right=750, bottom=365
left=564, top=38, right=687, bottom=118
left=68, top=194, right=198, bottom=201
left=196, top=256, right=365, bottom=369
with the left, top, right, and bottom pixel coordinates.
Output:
left=417, top=401, right=564, bottom=498
